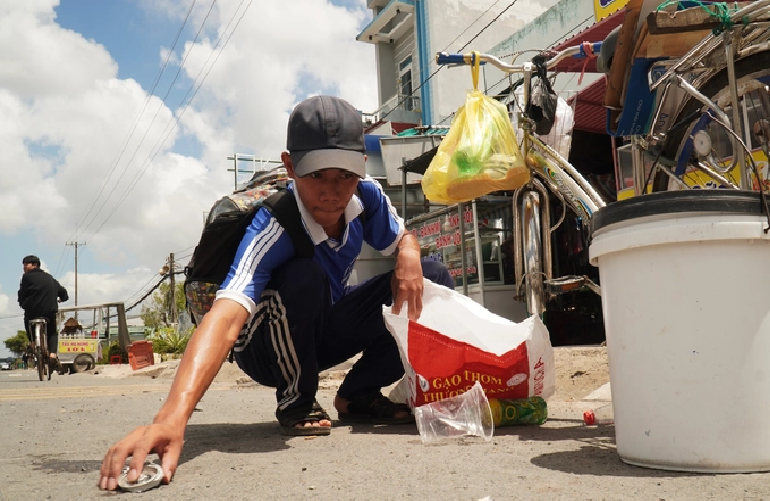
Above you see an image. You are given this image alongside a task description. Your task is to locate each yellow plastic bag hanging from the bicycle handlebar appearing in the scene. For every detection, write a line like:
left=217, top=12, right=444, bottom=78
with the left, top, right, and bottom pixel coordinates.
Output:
left=422, top=55, right=530, bottom=204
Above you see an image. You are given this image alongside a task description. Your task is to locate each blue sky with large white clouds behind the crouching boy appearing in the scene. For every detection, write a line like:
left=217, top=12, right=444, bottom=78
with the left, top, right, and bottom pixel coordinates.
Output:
left=0, top=0, right=378, bottom=356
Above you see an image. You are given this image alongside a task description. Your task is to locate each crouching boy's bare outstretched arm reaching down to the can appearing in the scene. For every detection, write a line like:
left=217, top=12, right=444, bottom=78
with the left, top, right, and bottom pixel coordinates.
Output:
left=99, top=299, right=248, bottom=490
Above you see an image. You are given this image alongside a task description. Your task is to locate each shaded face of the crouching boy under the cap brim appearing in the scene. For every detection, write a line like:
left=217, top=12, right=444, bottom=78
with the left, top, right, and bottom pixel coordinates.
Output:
left=291, top=169, right=358, bottom=228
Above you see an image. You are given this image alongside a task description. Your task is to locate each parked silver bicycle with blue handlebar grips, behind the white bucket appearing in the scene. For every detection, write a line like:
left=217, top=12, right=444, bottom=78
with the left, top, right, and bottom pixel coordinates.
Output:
left=436, top=0, right=770, bottom=315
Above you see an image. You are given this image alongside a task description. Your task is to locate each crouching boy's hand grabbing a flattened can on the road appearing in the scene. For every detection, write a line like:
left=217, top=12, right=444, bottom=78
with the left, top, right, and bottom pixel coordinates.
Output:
left=99, top=422, right=185, bottom=491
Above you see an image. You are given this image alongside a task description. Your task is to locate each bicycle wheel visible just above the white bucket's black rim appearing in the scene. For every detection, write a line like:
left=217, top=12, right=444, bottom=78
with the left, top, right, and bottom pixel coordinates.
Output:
left=652, top=51, right=770, bottom=191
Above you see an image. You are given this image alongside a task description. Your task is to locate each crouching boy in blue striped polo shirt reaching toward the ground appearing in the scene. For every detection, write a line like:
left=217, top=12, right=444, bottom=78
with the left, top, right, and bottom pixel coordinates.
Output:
left=99, top=96, right=454, bottom=490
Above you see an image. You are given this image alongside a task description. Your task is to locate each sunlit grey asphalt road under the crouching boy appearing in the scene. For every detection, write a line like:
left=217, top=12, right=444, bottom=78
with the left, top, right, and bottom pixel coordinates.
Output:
left=0, top=370, right=770, bottom=500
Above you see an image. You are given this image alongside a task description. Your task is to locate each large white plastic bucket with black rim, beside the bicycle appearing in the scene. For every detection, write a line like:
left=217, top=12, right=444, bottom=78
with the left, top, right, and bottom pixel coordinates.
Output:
left=589, top=190, right=770, bottom=473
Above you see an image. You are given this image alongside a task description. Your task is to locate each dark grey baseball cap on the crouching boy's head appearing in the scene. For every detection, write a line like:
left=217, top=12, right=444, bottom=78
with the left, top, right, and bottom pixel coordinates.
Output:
left=286, top=96, right=366, bottom=177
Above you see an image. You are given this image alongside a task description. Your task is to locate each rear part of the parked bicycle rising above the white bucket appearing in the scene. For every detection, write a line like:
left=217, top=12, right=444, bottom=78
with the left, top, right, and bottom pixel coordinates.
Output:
left=635, top=0, right=770, bottom=193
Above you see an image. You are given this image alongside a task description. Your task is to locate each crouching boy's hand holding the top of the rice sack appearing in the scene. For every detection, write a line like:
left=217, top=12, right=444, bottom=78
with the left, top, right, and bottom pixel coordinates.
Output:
left=391, top=233, right=423, bottom=320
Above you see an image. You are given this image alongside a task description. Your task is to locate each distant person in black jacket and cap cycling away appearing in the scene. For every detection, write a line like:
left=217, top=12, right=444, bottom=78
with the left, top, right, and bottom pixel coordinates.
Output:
left=19, top=255, right=69, bottom=362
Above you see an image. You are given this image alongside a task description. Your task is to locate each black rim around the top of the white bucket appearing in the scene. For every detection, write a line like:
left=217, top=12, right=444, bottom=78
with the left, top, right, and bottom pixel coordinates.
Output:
left=589, top=189, right=764, bottom=239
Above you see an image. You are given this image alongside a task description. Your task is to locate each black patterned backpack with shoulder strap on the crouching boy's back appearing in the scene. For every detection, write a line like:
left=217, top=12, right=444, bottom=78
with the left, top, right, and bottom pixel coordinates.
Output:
left=184, top=189, right=314, bottom=325
